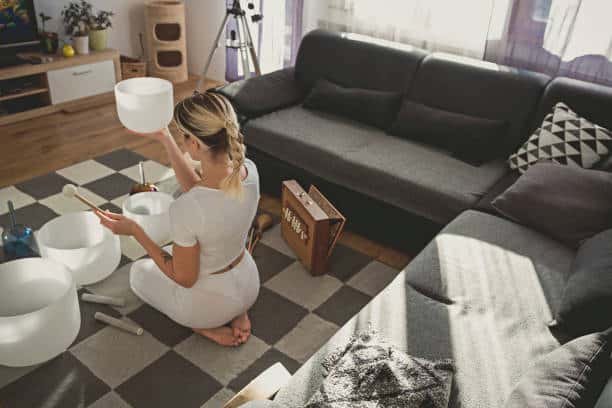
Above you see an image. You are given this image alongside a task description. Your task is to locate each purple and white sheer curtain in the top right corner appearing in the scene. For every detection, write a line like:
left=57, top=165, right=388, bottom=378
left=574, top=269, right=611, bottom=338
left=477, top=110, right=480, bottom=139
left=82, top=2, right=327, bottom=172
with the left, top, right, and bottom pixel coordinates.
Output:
left=485, top=0, right=612, bottom=85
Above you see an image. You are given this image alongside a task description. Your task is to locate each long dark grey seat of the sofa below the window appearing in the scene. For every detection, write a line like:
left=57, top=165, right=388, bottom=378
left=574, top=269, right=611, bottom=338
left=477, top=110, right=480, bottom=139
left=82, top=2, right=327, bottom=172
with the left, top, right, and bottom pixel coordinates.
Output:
left=243, top=106, right=508, bottom=224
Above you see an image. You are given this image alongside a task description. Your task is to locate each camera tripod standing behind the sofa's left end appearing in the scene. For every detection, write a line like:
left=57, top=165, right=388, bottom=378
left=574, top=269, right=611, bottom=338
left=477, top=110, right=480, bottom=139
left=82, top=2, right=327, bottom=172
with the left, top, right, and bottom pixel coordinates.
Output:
left=196, top=0, right=263, bottom=90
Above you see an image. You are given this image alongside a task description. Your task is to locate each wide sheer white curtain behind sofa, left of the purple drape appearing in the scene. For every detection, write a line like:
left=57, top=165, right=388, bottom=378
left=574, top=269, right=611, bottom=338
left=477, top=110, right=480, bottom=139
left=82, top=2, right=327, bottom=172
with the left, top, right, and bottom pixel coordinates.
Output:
left=319, top=0, right=493, bottom=58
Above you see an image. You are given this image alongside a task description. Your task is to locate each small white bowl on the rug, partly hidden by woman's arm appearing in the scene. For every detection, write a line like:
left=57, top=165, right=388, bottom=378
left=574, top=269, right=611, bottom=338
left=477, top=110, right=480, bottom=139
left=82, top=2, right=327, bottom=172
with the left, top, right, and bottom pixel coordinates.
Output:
left=123, top=191, right=174, bottom=245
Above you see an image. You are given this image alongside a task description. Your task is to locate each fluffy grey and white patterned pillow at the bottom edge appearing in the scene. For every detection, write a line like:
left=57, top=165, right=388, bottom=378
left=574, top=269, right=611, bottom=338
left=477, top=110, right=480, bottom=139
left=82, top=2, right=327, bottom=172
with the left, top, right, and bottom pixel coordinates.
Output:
left=304, top=332, right=454, bottom=408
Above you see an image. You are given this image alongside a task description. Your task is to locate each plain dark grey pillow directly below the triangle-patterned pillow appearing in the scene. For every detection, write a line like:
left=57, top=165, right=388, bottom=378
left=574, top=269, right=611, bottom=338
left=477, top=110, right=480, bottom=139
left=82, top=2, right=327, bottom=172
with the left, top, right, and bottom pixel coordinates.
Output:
left=492, top=162, right=612, bottom=246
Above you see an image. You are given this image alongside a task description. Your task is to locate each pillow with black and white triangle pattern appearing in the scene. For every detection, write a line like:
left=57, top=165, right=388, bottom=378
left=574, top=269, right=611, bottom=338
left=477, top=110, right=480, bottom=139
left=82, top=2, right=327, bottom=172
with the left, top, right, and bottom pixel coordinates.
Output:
left=508, top=102, right=612, bottom=173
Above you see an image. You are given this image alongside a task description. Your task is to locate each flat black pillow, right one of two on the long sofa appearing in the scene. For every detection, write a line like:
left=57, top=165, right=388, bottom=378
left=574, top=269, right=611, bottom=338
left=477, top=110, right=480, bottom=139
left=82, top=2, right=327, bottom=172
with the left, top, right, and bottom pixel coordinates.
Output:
left=389, top=100, right=506, bottom=165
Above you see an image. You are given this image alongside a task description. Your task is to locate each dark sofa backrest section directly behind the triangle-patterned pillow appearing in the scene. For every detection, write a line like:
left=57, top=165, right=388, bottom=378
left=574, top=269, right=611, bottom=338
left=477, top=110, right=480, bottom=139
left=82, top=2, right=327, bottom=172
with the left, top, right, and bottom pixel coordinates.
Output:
left=529, top=77, right=612, bottom=137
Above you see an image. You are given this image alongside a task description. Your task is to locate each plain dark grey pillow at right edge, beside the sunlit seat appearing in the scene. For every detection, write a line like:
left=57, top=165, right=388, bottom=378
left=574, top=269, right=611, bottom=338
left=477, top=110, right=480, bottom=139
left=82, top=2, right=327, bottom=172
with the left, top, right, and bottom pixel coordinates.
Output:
left=555, top=229, right=612, bottom=335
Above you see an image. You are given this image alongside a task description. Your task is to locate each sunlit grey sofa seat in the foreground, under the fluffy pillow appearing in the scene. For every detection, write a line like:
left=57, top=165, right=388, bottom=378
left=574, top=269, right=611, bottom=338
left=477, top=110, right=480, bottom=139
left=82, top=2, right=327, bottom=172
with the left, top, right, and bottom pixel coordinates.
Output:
left=275, top=211, right=572, bottom=408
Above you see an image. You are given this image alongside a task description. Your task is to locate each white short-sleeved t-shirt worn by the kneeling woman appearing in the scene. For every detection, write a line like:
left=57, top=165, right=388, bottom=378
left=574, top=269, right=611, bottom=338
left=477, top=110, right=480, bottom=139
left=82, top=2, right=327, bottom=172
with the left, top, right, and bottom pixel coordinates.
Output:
left=170, top=159, right=259, bottom=275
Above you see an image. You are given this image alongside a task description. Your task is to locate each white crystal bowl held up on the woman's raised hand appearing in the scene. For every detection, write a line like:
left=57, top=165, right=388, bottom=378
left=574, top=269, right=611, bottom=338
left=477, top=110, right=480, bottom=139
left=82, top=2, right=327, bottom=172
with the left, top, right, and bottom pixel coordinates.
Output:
left=115, top=77, right=174, bottom=133
